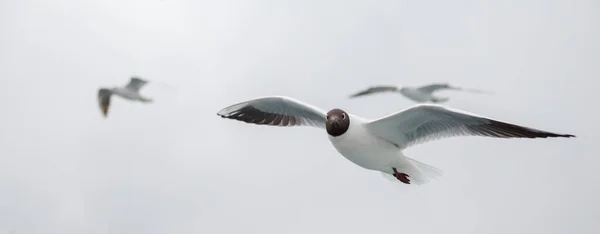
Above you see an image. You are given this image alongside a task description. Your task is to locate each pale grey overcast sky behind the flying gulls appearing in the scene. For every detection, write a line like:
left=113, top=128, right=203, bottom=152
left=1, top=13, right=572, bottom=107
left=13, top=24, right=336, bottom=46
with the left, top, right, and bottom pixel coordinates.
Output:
left=0, top=0, right=600, bottom=234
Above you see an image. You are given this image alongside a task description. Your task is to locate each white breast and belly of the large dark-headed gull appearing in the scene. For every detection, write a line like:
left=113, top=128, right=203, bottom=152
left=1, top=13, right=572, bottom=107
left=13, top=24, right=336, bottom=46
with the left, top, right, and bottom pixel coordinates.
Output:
left=329, top=115, right=400, bottom=171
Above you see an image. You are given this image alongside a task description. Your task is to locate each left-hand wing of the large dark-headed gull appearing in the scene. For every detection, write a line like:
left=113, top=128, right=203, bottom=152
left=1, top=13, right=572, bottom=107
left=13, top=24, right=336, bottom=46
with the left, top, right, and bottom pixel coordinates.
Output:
left=217, top=96, right=327, bottom=128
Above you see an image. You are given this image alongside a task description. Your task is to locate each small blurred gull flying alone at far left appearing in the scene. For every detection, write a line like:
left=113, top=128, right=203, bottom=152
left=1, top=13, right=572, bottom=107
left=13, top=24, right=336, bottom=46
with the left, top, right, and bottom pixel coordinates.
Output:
left=98, top=77, right=152, bottom=118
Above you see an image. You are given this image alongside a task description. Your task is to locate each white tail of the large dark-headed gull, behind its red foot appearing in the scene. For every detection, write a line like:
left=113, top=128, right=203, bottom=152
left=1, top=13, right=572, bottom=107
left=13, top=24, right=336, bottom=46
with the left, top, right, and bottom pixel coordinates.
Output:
left=382, top=157, right=444, bottom=185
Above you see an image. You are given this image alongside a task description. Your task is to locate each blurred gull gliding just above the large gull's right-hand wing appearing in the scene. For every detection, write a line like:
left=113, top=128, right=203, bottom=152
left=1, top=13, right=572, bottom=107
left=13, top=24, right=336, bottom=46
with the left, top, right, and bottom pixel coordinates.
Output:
left=350, top=83, right=487, bottom=103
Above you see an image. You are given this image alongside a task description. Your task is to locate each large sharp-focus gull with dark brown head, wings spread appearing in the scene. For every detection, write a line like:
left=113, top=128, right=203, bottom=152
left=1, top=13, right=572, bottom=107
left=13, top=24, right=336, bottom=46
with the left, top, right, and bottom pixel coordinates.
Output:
left=217, top=96, right=575, bottom=184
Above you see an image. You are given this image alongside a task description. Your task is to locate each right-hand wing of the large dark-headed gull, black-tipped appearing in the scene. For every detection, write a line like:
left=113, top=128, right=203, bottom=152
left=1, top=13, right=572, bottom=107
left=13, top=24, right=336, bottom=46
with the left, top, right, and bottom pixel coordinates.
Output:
left=367, top=104, right=575, bottom=148
